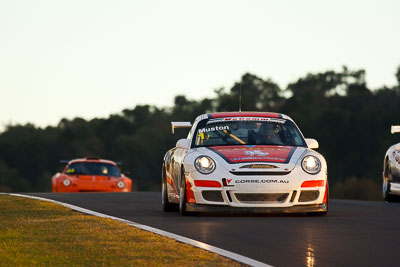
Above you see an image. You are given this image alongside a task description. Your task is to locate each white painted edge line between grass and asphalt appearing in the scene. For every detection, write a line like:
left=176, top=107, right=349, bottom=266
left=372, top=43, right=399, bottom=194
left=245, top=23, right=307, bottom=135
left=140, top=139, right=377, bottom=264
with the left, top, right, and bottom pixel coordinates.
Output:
left=7, top=193, right=272, bottom=267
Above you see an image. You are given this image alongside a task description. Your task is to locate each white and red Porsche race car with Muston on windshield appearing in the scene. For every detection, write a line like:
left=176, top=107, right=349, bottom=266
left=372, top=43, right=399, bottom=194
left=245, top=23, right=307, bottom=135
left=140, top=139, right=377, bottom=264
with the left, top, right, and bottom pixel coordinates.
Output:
left=162, top=112, right=329, bottom=214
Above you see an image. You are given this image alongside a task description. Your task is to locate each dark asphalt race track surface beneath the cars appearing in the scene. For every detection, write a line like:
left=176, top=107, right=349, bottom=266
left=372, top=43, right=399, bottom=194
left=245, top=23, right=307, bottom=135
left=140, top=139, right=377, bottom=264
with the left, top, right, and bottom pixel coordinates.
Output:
left=25, top=192, right=400, bottom=266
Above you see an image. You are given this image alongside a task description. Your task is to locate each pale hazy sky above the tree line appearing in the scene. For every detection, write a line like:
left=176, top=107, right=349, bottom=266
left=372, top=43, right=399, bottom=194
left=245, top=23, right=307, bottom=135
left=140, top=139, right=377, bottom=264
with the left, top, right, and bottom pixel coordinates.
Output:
left=0, top=0, right=400, bottom=129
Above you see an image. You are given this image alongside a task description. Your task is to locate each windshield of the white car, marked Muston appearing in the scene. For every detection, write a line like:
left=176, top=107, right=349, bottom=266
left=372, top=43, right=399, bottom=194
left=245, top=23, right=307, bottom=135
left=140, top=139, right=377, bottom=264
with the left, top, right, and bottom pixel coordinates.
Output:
left=193, top=117, right=306, bottom=147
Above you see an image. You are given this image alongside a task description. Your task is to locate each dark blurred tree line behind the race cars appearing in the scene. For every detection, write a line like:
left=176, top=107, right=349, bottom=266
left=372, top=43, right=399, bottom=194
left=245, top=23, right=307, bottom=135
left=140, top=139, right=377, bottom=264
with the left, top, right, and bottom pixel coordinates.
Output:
left=0, top=67, right=400, bottom=199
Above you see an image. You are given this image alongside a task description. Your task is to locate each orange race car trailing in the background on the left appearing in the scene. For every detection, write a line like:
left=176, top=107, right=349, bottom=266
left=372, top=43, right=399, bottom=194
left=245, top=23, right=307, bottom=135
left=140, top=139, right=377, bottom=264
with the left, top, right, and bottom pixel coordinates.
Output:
left=51, top=158, right=132, bottom=192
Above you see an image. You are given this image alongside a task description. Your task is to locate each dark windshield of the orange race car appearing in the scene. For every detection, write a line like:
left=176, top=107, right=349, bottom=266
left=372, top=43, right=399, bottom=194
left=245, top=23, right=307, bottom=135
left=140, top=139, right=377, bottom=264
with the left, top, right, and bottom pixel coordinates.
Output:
left=65, top=162, right=121, bottom=177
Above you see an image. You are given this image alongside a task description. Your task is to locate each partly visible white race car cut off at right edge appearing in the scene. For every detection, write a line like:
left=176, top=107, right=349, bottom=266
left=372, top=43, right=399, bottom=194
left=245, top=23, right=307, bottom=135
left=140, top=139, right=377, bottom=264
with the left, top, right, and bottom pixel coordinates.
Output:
left=382, top=125, right=400, bottom=202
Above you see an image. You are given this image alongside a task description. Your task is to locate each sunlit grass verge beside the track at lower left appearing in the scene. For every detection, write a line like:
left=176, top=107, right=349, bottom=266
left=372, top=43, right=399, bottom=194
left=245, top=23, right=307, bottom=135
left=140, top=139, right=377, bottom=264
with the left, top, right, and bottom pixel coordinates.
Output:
left=0, top=195, right=241, bottom=266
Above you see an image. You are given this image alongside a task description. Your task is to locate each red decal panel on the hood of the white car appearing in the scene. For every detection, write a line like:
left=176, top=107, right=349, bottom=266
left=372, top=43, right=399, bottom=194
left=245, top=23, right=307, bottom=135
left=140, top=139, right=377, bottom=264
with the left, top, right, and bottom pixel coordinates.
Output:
left=211, top=145, right=296, bottom=163
